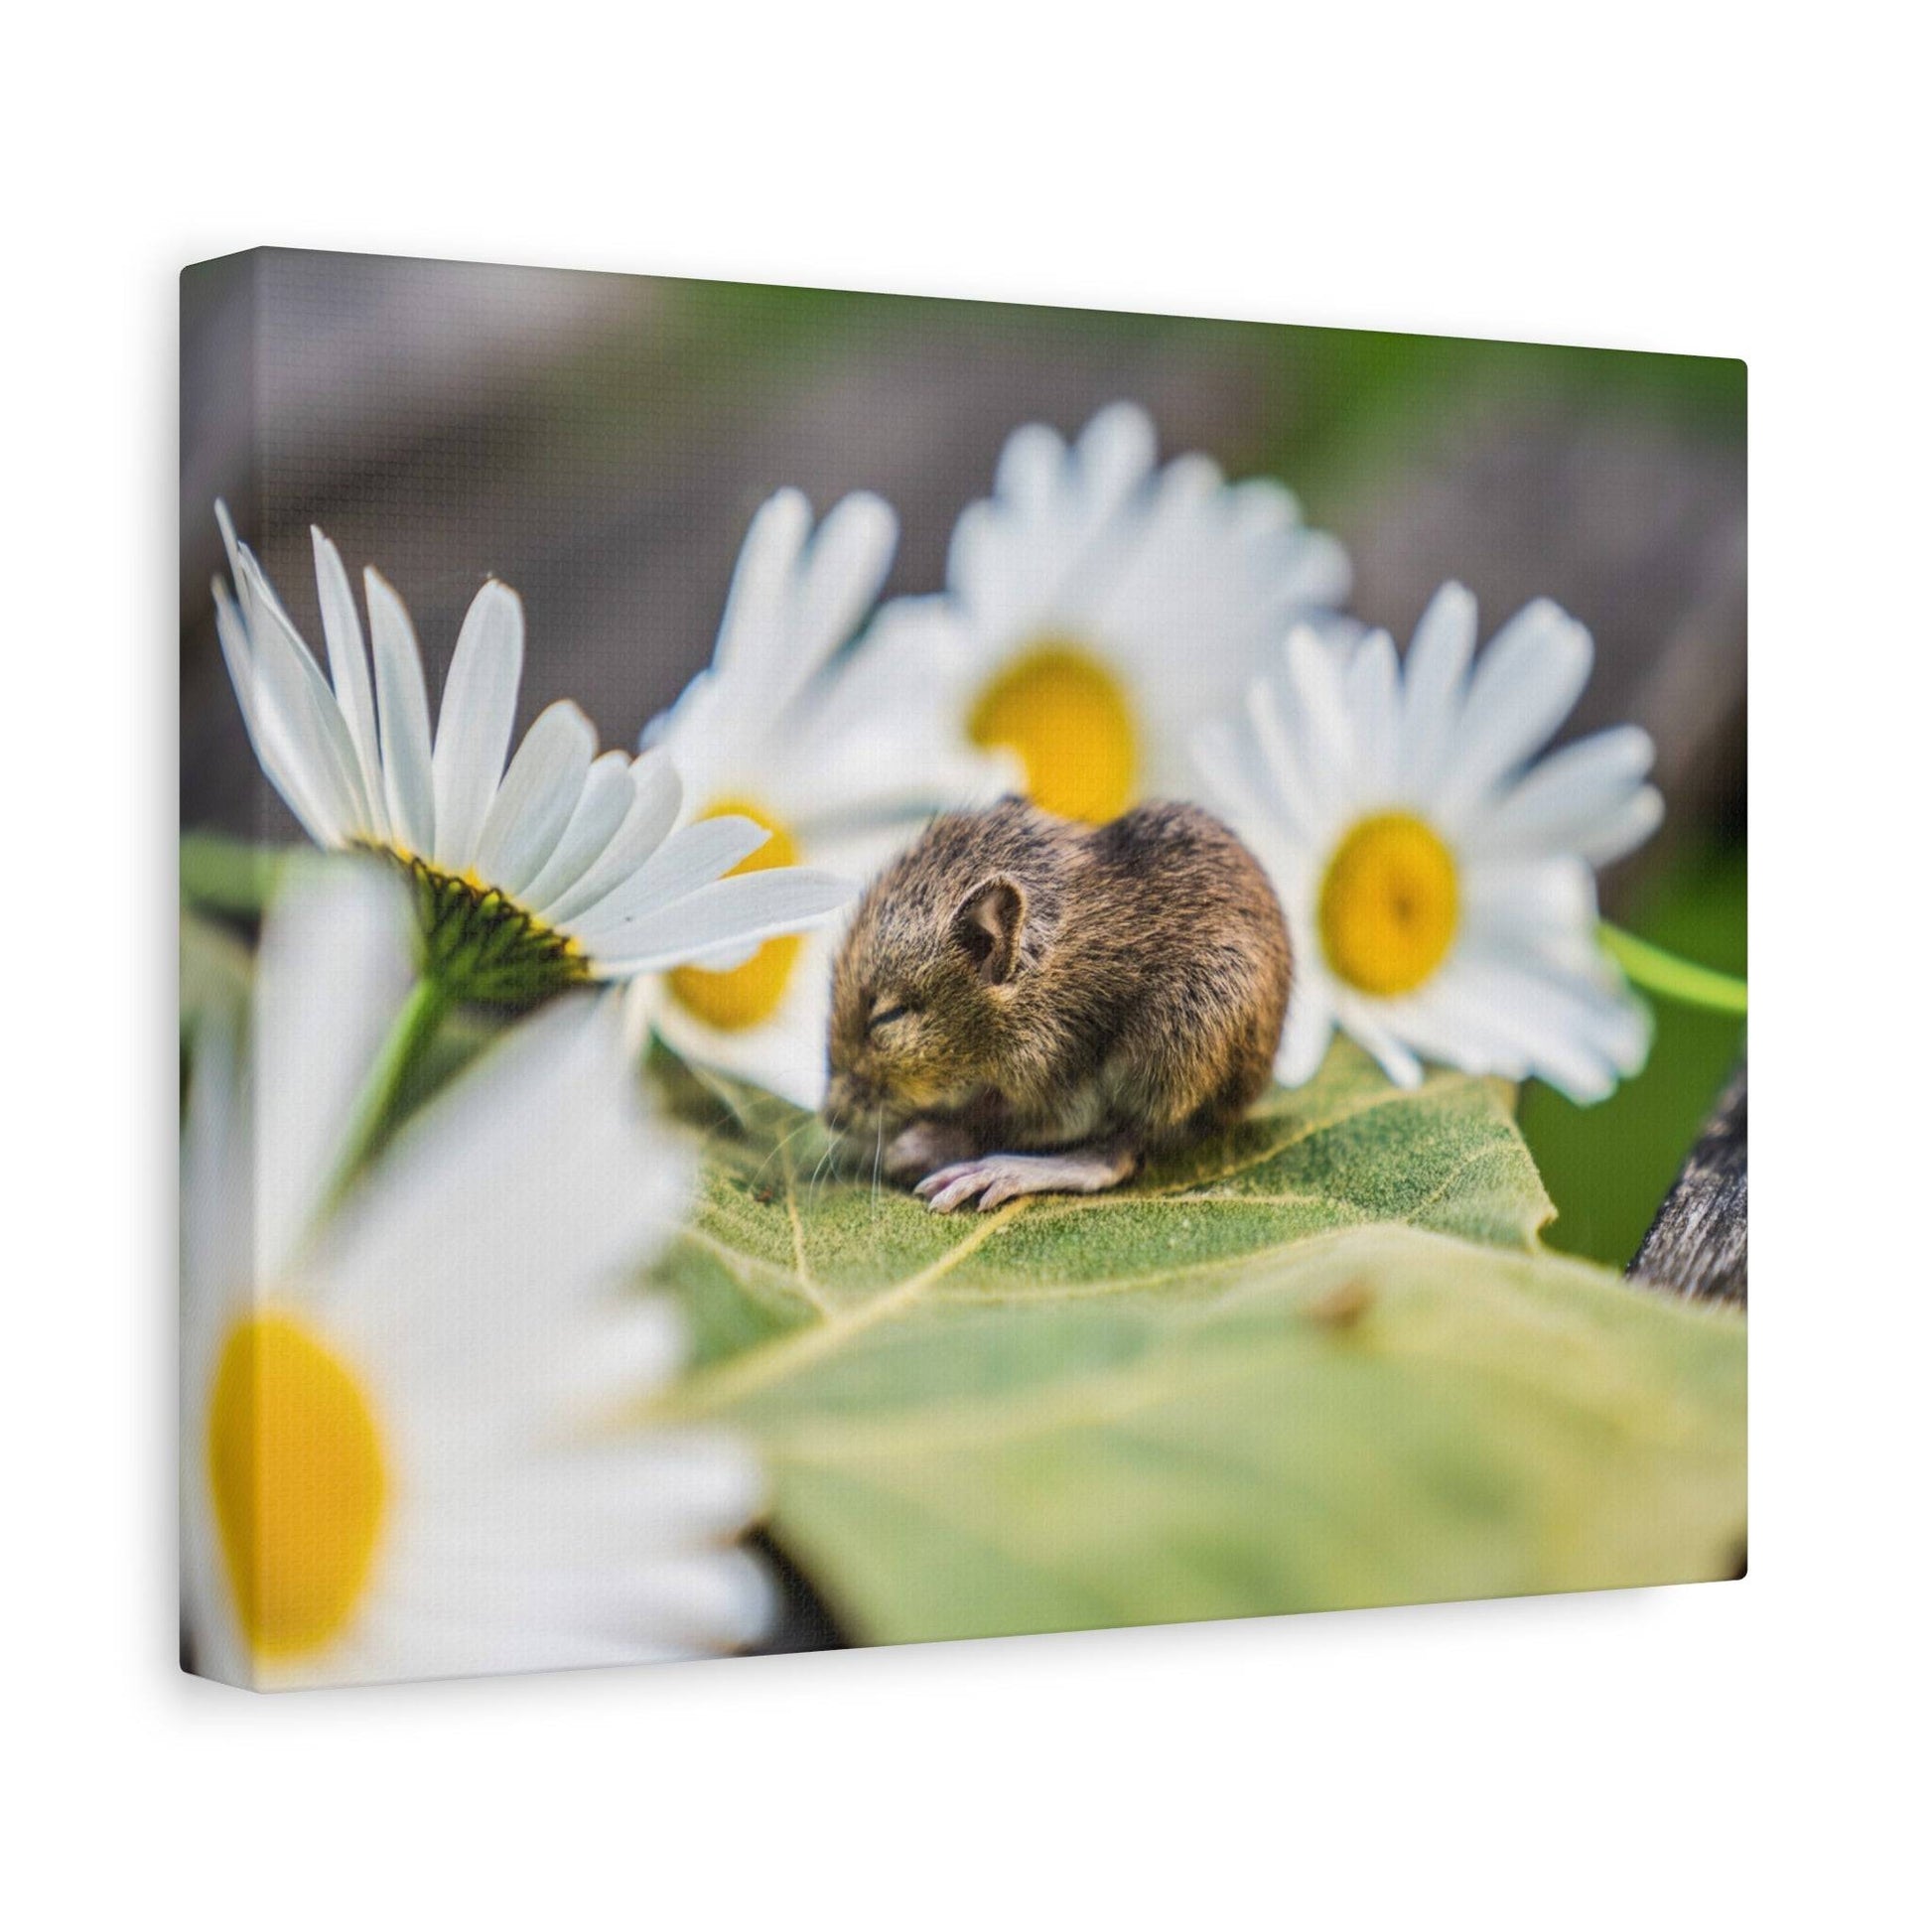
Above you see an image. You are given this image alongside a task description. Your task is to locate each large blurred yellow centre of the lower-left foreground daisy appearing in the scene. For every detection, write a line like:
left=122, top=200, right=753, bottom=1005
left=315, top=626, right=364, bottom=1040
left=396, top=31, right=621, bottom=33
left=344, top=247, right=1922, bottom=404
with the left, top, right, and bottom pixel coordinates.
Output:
left=207, top=1315, right=388, bottom=1656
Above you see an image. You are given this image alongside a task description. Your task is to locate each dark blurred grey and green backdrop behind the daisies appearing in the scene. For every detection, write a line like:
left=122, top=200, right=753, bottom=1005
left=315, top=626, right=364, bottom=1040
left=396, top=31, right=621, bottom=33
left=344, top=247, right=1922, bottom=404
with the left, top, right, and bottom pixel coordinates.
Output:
left=182, top=249, right=1744, bottom=1266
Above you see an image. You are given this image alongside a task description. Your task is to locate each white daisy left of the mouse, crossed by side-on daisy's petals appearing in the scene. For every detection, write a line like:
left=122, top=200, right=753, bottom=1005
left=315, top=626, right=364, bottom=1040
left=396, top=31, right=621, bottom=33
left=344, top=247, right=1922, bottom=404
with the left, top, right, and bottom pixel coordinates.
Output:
left=631, top=490, right=1007, bottom=1107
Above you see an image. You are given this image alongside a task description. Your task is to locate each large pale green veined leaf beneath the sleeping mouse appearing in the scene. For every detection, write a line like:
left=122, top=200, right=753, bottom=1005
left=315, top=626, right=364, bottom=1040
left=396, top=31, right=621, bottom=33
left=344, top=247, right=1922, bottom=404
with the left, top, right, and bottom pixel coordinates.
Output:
left=659, top=1047, right=1744, bottom=1642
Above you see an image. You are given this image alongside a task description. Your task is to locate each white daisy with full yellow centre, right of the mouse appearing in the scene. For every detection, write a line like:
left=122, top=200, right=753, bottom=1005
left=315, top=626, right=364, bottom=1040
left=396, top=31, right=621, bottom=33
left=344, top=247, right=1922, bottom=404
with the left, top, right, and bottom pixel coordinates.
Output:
left=1198, top=584, right=1664, bottom=1101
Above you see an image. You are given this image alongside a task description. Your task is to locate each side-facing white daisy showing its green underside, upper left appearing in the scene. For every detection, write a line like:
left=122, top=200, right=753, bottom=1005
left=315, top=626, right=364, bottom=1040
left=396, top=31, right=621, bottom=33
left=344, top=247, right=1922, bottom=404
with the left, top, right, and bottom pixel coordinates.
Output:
left=214, top=504, right=852, bottom=1001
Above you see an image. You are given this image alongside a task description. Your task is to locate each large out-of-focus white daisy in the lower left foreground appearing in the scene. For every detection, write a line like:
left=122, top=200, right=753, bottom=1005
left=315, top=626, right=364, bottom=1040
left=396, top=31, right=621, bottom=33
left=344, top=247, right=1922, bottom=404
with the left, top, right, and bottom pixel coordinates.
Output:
left=182, top=862, right=770, bottom=1689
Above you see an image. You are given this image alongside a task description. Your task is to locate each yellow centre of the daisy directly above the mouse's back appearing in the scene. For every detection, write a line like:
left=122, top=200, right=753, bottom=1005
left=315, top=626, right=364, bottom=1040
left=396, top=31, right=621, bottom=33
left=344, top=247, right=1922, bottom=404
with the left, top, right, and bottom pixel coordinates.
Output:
left=966, top=637, right=1140, bottom=825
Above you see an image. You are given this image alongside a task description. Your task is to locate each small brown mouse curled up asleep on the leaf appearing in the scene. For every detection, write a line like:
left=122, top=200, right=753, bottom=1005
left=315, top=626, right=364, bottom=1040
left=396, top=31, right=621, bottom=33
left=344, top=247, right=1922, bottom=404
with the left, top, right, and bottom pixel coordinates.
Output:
left=823, top=798, right=1293, bottom=1213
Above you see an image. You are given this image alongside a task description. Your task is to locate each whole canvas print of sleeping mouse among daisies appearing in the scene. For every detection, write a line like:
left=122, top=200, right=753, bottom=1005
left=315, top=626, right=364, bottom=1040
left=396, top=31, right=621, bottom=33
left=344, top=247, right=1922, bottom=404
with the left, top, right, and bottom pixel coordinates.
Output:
left=180, top=249, right=1748, bottom=1689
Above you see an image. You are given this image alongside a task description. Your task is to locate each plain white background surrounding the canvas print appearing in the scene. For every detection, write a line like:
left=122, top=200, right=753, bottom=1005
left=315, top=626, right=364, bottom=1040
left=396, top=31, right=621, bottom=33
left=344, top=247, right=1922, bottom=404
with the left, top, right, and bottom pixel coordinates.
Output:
left=0, top=0, right=1932, bottom=1928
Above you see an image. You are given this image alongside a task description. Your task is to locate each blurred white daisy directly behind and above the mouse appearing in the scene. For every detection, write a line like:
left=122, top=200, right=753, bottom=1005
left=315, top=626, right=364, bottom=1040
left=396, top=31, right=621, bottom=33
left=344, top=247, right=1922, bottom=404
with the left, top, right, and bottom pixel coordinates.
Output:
left=881, top=402, right=1348, bottom=821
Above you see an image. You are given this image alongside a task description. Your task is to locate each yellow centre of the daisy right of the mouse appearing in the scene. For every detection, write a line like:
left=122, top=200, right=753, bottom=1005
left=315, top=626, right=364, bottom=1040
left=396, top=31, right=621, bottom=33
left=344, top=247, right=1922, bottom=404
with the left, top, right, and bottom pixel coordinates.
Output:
left=1319, top=811, right=1458, bottom=999
